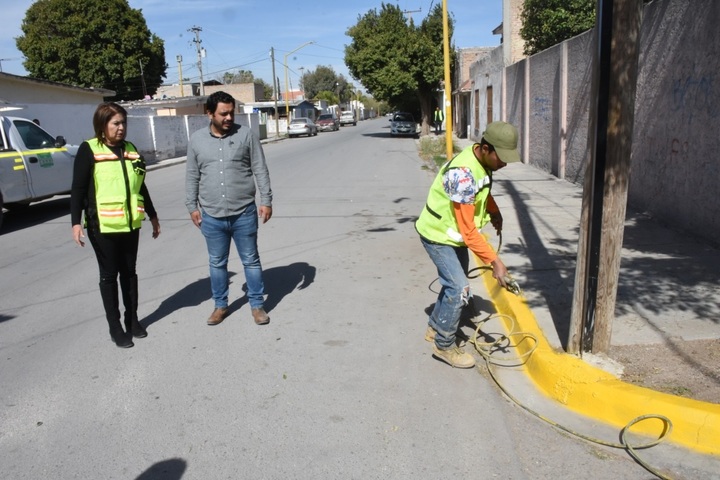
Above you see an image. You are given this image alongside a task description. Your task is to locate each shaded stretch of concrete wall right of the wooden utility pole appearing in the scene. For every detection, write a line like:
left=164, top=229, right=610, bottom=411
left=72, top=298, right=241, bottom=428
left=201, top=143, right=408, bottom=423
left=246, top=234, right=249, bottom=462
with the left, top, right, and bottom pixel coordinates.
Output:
left=630, top=0, right=720, bottom=240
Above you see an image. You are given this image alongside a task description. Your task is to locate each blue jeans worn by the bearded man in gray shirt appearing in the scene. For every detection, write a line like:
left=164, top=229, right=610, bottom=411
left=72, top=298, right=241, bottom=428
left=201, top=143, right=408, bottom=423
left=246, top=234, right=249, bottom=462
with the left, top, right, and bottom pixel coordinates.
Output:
left=200, top=203, right=265, bottom=308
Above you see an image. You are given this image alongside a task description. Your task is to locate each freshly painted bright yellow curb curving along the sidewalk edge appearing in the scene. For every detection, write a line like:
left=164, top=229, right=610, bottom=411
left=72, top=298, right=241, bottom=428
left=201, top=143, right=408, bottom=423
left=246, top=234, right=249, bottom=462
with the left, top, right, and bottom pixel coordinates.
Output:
left=482, top=274, right=720, bottom=455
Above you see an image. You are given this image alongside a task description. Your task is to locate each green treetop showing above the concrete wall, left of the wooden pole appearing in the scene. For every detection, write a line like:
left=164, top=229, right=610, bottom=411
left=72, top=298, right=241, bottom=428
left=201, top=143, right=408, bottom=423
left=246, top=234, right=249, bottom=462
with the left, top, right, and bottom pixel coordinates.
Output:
left=520, top=0, right=596, bottom=55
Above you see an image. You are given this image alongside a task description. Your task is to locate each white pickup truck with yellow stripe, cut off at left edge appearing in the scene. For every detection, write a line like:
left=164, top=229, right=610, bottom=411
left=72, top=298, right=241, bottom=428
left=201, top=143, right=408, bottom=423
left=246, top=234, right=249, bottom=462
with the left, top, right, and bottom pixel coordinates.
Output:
left=0, top=115, right=77, bottom=227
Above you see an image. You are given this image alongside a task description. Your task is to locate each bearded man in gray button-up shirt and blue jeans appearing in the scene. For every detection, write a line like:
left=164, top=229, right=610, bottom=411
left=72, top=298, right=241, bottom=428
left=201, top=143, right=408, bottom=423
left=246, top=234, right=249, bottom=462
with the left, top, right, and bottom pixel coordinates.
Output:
left=185, top=92, right=272, bottom=325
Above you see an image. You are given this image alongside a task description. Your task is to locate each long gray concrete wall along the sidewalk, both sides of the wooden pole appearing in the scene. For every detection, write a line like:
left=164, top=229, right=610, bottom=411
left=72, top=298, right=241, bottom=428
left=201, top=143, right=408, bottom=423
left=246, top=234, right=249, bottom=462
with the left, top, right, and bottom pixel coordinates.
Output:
left=471, top=0, right=720, bottom=245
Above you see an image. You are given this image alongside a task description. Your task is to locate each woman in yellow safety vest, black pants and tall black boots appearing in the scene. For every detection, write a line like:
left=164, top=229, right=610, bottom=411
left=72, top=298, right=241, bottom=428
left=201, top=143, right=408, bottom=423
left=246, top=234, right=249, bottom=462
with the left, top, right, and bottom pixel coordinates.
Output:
left=70, top=102, right=160, bottom=348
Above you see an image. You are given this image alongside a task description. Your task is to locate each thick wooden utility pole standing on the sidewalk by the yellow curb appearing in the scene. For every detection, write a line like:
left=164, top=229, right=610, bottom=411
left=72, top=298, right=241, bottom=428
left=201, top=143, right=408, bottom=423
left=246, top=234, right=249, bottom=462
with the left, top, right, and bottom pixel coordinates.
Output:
left=568, top=0, right=642, bottom=353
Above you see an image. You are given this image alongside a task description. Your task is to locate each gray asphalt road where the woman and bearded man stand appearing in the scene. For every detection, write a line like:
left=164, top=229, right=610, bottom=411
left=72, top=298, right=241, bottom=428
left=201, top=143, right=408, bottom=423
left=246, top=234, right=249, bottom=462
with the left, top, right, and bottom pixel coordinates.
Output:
left=0, top=118, right=651, bottom=480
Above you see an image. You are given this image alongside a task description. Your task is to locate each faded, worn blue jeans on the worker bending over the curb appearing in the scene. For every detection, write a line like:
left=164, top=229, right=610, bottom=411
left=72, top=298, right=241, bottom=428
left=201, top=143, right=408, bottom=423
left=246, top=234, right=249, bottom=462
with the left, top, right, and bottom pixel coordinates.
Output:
left=420, top=237, right=470, bottom=350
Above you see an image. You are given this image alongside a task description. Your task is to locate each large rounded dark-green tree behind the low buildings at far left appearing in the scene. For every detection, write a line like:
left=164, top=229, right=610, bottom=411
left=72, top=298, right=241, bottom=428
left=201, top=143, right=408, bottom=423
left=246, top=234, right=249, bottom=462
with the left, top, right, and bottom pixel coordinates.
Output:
left=15, top=0, right=167, bottom=100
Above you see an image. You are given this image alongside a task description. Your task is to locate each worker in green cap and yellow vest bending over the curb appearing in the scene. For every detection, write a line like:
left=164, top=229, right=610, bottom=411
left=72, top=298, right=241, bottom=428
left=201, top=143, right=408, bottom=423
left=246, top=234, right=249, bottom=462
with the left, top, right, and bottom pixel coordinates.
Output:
left=415, top=122, right=520, bottom=368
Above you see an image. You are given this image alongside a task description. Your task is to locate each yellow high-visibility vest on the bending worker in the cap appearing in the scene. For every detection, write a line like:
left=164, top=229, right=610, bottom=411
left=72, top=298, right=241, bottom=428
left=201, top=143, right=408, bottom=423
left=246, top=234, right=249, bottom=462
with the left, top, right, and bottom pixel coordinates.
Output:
left=415, top=146, right=492, bottom=247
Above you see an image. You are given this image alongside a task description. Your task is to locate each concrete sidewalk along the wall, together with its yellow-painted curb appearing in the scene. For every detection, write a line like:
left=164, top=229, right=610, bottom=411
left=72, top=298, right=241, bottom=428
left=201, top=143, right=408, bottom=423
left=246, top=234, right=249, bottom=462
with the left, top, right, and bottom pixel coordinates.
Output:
left=448, top=133, right=720, bottom=459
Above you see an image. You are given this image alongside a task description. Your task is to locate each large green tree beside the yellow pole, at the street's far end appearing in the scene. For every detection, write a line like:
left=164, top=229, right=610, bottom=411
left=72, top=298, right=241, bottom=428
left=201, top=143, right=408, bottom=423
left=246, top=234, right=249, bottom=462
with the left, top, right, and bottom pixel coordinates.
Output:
left=345, top=3, right=454, bottom=134
